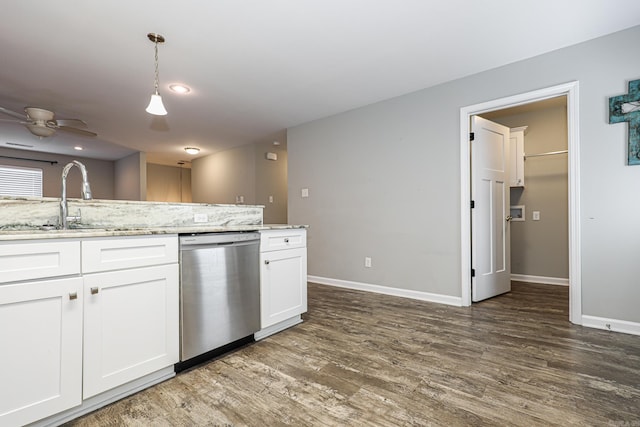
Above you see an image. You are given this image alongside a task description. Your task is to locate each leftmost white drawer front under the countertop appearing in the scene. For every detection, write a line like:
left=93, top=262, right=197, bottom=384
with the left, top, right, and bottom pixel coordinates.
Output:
left=0, top=240, right=80, bottom=283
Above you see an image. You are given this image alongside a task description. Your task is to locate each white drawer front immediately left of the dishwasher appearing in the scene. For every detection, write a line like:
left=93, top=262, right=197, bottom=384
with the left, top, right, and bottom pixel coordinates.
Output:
left=82, top=235, right=178, bottom=273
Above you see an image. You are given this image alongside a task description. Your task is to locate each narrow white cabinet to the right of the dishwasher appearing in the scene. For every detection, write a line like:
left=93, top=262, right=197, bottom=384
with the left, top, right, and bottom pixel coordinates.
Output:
left=256, top=229, right=307, bottom=339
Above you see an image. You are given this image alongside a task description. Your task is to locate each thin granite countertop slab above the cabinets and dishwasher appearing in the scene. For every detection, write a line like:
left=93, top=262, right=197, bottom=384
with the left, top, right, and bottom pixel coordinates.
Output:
left=0, top=224, right=308, bottom=241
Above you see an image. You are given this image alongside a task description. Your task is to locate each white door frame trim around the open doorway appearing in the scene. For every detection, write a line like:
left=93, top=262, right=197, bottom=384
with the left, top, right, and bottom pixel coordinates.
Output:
left=460, top=82, right=582, bottom=324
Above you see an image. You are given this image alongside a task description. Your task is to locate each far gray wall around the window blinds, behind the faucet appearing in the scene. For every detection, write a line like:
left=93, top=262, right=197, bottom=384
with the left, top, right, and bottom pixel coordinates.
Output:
left=0, top=148, right=114, bottom=199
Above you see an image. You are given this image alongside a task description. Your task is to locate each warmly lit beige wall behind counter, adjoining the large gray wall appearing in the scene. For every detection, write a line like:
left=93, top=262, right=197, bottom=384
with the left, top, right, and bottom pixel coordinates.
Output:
left=191, top=131, right=287, bottom=224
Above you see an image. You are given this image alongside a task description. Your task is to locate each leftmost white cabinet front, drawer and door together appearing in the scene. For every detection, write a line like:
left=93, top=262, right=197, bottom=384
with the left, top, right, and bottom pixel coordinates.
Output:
left=0, top=241, right=82, bottom=426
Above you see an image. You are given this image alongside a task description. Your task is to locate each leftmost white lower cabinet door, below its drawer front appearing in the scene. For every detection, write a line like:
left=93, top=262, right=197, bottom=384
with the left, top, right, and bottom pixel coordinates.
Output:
left=0, top=277, right=82, bottom=426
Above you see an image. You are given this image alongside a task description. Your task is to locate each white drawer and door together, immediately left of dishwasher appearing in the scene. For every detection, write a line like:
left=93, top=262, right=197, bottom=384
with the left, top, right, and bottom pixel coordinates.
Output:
left=82, top=236, right=179, bottom=399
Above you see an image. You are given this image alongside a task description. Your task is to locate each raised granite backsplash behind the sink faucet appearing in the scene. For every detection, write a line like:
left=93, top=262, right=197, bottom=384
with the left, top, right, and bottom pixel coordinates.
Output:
left=0, top=197, right=264, bottom=230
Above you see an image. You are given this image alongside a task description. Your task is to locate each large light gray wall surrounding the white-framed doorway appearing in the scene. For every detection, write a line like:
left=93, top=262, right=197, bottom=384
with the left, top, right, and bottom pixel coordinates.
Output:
left=288, top=27, right=640, bottom=322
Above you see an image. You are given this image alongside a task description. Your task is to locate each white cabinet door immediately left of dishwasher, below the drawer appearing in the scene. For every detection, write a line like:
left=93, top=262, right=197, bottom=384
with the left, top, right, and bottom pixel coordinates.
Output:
left=83, top=264, right=179, bottom=399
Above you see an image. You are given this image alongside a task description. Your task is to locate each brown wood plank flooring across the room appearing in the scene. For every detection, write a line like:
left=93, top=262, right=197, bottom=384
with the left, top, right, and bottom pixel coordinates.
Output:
left=68, top=282, right=640, bottom=427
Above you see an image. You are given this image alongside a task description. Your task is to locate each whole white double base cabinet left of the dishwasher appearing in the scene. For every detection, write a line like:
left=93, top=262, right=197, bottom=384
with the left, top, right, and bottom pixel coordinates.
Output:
left=0, top=235, right=179, bottom=426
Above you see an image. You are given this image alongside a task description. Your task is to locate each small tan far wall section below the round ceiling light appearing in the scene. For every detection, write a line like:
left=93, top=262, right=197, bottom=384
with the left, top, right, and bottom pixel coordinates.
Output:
left=147, top=163, right=191, bottom=203
